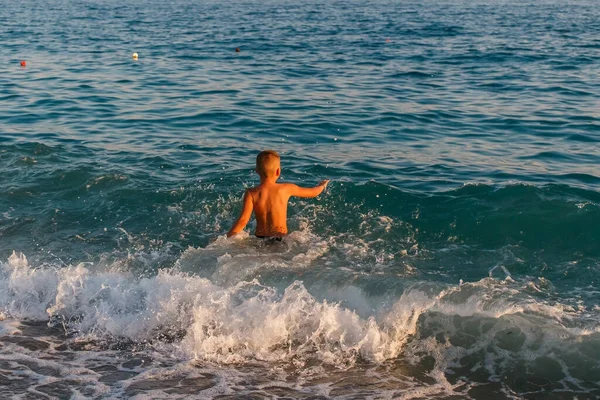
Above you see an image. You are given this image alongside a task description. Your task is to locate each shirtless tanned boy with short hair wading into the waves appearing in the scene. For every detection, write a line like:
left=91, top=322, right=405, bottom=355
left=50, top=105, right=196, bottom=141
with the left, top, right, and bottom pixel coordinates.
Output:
left=227, top=150, right=329, bottom=239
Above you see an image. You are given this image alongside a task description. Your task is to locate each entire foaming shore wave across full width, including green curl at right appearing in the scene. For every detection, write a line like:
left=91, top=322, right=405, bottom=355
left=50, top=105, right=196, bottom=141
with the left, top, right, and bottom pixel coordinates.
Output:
left=0, top=250, right=600, bottom=398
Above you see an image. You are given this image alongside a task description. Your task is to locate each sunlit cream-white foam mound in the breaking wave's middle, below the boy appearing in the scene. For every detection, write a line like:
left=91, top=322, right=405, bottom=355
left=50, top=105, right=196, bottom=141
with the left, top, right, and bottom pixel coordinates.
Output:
left=184, top=281, right=427, bottom=365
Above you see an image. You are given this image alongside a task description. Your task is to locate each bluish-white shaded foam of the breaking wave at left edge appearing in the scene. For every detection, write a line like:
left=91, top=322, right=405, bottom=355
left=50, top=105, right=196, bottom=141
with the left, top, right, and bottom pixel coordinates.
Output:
left=0, top=253, right=215, bottom=341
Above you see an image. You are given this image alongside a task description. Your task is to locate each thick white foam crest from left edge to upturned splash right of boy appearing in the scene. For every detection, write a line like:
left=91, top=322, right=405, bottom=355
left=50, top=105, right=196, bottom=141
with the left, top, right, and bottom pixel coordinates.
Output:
left=0, top=254, right=429, bottom=365
